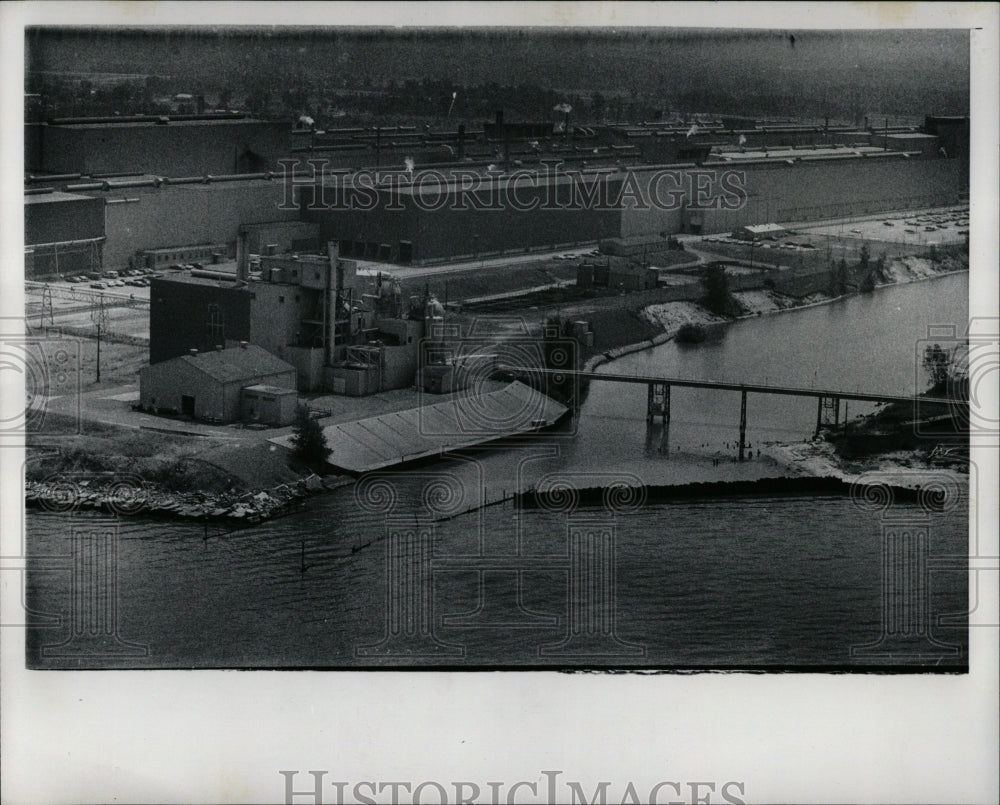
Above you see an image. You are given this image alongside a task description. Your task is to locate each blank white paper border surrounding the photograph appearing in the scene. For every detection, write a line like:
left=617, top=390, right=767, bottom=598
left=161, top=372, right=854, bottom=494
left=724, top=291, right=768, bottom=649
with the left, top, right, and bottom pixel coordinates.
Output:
left=0, top=2, right=1000, bottom=805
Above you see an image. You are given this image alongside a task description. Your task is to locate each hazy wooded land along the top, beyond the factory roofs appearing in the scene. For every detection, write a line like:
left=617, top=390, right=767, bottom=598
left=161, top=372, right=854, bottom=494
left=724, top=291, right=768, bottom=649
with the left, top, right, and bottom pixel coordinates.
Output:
left=25, top=28, right=969, bottom=127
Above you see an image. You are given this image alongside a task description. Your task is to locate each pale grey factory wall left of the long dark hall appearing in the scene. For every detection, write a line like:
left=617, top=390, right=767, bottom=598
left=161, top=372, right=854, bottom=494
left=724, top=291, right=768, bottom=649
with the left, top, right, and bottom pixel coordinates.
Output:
left=100, top=179, right=299, bottom=269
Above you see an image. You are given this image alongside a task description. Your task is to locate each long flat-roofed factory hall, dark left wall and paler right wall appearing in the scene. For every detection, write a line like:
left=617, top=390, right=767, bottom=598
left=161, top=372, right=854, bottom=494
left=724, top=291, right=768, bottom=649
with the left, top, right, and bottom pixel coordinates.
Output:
left=303, top=141, right=968, bottom=264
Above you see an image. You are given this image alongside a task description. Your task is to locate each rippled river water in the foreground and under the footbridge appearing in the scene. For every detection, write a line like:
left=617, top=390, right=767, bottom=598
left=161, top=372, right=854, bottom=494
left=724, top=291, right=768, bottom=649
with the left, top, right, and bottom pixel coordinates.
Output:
left=27, top=274, right=968, bottom=670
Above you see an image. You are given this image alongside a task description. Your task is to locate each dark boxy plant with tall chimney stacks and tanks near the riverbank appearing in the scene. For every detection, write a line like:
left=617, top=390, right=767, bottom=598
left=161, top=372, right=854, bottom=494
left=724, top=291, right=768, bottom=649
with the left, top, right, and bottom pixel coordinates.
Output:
left=150, top=243, right=444, bottom=396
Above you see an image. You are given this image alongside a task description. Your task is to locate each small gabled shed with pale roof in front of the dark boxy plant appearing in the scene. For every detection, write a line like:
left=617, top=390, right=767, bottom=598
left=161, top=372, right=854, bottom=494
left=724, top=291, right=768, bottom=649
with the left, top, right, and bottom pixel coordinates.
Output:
left=139, top=342, right=297, bottom=425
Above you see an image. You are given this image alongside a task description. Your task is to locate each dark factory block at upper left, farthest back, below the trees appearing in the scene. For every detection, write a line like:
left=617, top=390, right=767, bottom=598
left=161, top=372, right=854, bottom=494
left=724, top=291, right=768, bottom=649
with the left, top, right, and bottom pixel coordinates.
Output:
left=25, top=120, right=291, bottom=176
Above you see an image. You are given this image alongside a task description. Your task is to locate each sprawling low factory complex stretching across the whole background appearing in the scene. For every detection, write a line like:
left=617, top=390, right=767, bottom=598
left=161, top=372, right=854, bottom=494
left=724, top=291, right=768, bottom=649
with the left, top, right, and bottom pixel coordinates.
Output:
left=17, top=109, right=968, bottom=274
